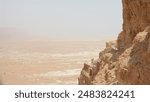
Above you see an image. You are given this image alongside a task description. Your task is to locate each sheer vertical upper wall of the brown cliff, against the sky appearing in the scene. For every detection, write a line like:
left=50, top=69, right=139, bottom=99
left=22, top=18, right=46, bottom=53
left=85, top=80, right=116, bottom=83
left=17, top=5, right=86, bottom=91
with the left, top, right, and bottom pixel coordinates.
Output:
left=118, top=0, right=150, bottom=47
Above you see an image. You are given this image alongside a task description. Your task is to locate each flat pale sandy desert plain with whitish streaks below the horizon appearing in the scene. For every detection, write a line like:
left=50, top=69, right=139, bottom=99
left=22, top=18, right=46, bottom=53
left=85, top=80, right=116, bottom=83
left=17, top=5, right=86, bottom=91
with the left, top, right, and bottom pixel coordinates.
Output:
left=0, top=41, right=104, bottom=85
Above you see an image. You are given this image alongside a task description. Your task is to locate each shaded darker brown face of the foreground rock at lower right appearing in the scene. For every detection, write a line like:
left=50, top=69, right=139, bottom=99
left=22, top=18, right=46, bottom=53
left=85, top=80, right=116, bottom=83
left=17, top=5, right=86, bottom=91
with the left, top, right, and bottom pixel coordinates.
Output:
left=126, top=32, right=150, bottom=85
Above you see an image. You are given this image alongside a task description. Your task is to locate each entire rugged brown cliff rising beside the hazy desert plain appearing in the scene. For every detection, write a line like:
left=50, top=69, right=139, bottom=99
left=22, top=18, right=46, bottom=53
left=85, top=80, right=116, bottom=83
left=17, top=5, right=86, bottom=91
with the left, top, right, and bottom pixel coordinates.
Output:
left=79, top=0, right=150, bottom=84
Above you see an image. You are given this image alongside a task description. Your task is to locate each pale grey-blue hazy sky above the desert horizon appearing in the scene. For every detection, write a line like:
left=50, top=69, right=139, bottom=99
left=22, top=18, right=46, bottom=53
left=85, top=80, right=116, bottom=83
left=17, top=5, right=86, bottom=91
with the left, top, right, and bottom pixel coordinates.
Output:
left=0, top=0, right=122, bottom=40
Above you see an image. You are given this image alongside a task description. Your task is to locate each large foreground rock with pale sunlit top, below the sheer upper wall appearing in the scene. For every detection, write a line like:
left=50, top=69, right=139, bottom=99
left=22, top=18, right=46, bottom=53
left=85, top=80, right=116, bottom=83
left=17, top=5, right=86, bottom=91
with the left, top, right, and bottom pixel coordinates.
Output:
left=116, top=27, right=150, bottom=84
